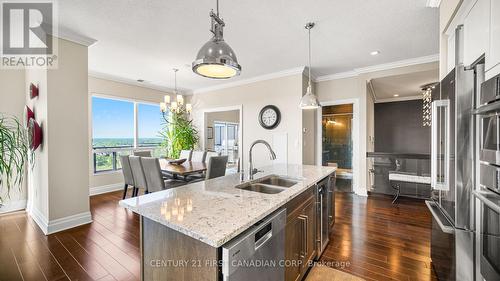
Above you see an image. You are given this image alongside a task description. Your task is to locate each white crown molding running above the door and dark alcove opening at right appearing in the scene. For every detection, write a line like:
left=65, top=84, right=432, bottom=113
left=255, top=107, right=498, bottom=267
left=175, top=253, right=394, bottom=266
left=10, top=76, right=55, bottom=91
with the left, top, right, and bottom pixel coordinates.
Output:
left=315, top=54, right=439, bottom=82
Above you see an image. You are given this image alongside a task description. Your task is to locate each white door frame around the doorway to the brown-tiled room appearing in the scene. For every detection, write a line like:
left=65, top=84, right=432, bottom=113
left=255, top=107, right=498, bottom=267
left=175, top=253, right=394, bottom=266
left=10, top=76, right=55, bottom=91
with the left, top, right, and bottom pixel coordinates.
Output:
left=316, top=98, right=361, bottom=193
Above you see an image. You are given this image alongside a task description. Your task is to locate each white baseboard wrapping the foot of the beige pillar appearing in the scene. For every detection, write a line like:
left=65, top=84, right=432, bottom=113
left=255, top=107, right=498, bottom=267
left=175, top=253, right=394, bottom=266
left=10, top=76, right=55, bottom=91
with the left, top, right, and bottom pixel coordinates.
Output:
left=29, top=208, right=92, bottom=235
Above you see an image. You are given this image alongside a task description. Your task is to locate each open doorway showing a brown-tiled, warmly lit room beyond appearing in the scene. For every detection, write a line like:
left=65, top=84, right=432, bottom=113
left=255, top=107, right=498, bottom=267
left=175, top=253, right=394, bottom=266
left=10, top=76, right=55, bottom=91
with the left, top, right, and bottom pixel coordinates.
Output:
left=321, top=103, right=354, bottom=192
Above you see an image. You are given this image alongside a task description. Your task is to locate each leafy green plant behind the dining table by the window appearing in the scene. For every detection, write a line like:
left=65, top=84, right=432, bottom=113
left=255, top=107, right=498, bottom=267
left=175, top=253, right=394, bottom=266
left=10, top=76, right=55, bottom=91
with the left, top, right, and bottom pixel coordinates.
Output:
left=160, top=107, right=199, bottom=159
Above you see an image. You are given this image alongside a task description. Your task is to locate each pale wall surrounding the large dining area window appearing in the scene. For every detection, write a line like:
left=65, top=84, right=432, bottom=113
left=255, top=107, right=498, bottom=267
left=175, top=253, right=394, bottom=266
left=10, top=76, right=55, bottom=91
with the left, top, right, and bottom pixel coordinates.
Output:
left=88, top=77, right=175, bottom=189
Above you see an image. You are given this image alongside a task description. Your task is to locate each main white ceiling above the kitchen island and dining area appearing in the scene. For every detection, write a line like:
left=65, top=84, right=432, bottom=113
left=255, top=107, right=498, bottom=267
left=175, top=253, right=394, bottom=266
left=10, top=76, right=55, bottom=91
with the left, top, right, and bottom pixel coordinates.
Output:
left=58, top=0, right=439, bottom=90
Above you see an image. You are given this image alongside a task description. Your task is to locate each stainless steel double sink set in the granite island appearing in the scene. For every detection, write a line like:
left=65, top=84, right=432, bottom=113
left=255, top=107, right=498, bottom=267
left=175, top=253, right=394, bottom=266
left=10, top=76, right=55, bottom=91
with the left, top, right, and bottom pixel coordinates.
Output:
left=235, top=175, right=298, bottom=194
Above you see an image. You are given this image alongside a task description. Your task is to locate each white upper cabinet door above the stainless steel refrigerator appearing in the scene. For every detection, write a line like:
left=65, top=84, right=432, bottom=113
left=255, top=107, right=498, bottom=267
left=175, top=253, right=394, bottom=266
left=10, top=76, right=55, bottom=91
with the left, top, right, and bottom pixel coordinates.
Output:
left=464, top=0, right=490, bottom=65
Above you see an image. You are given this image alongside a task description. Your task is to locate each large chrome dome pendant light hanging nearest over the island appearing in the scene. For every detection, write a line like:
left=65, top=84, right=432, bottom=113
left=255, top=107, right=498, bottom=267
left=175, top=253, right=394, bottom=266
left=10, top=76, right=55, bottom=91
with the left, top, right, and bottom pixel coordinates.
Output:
left=193, top=0, right=241, bottom=79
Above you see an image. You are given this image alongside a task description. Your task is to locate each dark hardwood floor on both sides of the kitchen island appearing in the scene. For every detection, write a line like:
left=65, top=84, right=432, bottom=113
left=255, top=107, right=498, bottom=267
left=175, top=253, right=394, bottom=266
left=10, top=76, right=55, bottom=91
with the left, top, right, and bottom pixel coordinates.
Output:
left=0, top=189, right=435, bottom=281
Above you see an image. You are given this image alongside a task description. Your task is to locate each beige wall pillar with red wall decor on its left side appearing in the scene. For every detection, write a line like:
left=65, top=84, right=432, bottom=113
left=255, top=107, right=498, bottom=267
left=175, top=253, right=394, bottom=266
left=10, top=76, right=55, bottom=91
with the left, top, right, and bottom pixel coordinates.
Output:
left=25, top=39, right=91, bottom=233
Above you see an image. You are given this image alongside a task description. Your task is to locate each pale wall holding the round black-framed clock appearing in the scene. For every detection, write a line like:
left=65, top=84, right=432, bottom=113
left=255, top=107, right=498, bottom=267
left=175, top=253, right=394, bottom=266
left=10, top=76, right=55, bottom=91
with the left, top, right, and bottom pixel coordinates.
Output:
left=192, top=74, right=302, bottom=169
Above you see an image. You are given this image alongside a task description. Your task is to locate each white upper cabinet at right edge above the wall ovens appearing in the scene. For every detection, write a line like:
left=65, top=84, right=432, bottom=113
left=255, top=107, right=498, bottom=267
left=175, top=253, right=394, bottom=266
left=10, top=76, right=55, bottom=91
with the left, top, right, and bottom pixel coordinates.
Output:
left=486, top=0, right=500, bottom=70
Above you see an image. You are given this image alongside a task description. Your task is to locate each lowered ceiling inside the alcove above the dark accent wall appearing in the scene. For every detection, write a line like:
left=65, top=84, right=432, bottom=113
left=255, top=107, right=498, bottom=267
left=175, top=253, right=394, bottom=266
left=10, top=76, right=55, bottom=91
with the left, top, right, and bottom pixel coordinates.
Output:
left=371, top=66, right=439, bottom=102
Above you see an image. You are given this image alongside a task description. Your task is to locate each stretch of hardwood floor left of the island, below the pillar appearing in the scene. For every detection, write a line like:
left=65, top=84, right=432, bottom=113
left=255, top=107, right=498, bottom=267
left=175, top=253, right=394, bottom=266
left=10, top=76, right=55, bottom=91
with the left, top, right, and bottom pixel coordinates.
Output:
left=0, top=191, right=140, bottom=281
